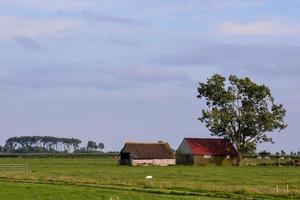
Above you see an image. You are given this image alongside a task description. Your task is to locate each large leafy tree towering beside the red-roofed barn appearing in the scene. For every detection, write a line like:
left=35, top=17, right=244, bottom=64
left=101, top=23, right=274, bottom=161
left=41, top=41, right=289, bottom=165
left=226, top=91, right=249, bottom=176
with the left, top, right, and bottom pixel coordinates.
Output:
left=197, top=74, right=287, bottom=165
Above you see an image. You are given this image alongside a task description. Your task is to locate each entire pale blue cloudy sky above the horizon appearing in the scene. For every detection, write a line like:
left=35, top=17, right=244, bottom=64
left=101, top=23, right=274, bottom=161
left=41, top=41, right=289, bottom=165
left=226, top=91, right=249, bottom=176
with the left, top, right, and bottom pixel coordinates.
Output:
left=0, top=0, right=300, bottom=152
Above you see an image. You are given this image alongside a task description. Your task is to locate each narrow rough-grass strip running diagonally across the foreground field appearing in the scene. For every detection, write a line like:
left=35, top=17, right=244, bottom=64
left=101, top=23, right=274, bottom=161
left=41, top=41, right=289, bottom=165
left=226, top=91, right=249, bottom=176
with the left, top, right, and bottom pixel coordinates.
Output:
left=0, top=178, right=293, bottom=200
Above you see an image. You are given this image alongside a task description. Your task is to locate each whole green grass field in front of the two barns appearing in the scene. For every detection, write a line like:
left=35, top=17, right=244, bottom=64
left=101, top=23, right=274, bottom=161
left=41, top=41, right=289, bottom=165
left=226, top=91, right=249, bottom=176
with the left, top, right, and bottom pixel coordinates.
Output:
left=0, top=157, right=300, bottom=200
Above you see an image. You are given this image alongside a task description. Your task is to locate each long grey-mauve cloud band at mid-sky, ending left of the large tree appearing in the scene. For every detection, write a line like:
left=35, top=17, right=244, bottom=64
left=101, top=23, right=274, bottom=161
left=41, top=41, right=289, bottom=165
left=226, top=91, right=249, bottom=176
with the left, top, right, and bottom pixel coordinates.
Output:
left=0, top=66, right=189, bottom=89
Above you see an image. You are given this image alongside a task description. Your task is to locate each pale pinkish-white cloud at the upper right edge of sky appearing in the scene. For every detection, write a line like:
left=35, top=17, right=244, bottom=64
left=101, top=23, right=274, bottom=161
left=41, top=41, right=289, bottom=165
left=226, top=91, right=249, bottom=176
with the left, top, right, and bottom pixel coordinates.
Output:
left=218, top=20, right=300, bottom=35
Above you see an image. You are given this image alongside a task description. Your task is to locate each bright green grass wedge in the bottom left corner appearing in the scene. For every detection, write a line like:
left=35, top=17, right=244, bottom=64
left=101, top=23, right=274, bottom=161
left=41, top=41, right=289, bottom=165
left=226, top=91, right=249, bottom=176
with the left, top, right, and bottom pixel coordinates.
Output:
left=0, top=181, right=215, bottom=200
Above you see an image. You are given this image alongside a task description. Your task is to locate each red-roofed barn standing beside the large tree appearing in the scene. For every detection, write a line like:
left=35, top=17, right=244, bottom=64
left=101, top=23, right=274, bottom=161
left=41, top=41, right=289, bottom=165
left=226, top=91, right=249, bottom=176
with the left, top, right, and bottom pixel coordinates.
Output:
left=176, top=138, right=237, bottom=165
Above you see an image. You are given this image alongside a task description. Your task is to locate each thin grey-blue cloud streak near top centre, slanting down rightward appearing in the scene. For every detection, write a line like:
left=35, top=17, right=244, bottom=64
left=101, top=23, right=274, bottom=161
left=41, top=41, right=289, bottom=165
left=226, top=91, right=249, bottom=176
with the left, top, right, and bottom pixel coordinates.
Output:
left=82, top=10, right=147, bottom=26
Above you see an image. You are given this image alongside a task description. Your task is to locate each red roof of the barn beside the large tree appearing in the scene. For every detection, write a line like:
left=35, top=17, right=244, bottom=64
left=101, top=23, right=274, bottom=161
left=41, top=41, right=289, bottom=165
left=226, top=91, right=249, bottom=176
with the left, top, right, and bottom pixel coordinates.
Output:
left=184, top=138, right=237, bottom=156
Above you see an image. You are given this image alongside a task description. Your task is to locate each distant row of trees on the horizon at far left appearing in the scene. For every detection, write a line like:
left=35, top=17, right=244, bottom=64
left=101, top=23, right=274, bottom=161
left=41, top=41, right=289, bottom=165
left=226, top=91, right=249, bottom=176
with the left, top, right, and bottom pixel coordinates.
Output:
left=0, top=136, right=104, bottom=153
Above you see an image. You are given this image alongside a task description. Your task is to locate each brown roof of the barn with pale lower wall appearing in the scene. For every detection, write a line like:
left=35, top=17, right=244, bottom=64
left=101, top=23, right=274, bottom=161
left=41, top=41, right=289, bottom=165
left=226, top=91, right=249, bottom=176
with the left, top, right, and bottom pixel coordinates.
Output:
left=121, top=142, right=174, bottom=159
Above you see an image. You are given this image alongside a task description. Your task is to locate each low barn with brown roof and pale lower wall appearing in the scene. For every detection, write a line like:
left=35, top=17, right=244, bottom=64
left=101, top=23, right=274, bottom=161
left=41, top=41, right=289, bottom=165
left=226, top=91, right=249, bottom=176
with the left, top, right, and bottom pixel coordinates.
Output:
left=119, top=142, right=176, bottom=166
